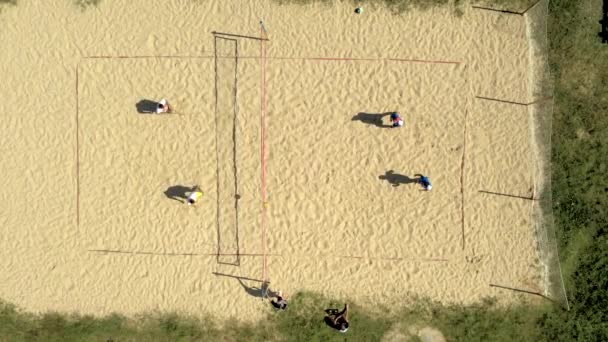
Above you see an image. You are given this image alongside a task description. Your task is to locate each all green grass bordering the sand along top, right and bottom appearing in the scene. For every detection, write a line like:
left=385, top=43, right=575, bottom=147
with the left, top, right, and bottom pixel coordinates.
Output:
left=0, top=0, right=608, bottom=341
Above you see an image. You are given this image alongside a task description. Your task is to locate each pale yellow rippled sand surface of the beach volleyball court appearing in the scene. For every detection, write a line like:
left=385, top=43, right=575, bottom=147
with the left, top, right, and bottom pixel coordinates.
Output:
left=0, top=0, right=542, bottom=320
